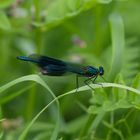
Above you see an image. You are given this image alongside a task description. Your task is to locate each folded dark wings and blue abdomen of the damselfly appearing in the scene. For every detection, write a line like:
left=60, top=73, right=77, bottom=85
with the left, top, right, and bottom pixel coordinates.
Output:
left=17, top=54, right=85, bottom=76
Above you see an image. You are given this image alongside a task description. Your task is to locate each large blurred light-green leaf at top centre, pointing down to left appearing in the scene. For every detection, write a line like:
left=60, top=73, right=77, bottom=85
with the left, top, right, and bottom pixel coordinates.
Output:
left=32, top=0, right=96, bottom=29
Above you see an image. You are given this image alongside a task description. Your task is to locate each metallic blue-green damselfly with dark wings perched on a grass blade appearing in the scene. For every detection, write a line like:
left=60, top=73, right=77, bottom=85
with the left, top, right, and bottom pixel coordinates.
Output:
left=17, top=54, right=104, bottom=90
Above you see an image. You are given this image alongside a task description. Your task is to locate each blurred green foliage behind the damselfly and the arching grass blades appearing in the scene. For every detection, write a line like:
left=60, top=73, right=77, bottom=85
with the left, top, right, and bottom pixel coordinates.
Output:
left=0, top=0, right=140, bottom=140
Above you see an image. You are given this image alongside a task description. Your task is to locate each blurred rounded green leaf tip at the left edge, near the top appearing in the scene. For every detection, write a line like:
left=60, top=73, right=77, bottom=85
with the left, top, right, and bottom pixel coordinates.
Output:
left=0, top=12, right=11, bottom=31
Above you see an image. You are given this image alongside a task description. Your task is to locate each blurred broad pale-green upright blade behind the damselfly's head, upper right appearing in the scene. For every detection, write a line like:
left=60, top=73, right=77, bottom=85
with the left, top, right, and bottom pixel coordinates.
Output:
left=109, top=14, right=125, bottom=80
